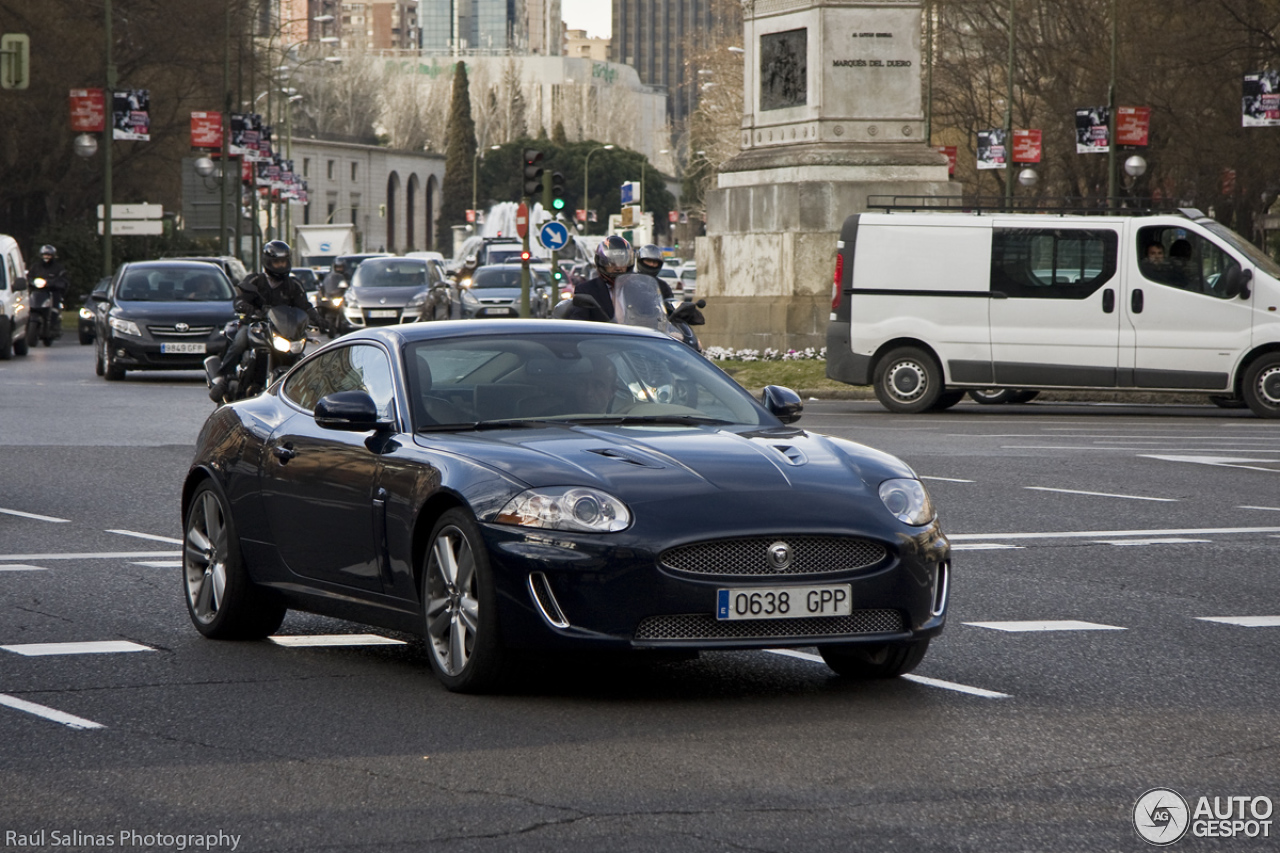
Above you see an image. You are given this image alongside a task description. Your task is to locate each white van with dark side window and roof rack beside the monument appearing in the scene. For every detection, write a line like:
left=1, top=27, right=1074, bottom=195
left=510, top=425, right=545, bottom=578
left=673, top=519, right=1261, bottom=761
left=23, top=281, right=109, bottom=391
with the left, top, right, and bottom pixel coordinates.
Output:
left=827, top=210, right=1280, bottom=418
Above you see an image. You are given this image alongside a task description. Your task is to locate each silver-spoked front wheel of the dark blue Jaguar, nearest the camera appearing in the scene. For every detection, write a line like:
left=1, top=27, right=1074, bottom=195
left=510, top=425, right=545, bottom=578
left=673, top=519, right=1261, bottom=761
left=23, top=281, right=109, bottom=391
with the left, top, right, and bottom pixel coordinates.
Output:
left=421, top=508, right=503, bottom=693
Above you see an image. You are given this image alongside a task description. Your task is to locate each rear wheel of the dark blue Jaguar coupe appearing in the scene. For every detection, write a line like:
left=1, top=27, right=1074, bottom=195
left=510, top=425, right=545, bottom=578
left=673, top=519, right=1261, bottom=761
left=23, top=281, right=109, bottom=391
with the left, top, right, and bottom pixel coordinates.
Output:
left=182, top=480, right=287, bottom=639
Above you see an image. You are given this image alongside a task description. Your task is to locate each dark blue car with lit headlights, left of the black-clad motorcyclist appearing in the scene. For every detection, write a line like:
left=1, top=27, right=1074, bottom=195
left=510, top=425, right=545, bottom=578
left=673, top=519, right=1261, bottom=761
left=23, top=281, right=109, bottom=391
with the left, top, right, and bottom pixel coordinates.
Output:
left=91, top=260, right=236, bottom=382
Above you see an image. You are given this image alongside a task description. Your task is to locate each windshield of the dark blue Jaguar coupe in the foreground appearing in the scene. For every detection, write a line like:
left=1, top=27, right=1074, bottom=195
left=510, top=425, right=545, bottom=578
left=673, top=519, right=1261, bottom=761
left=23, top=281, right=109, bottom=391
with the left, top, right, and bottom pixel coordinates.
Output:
left=404, top=333, right=780, bottom=432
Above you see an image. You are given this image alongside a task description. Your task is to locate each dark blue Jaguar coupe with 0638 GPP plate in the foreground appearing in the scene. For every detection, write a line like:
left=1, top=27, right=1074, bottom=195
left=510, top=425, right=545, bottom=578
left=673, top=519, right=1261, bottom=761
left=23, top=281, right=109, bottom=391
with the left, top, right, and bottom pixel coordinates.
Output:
left=182, top=320, right=950, bottom=692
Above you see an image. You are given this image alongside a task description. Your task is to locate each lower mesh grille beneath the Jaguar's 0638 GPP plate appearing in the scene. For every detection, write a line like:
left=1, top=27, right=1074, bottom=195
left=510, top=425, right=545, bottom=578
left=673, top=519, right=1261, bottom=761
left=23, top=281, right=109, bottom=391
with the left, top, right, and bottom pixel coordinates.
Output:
left=635, top=610, right=906, bottom=640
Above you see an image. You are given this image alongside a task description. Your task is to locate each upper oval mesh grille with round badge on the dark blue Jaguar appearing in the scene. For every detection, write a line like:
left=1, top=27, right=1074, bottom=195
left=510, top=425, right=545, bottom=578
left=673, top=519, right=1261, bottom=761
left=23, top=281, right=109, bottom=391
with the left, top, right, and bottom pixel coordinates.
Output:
left=658, top=535, right=887, bottom=578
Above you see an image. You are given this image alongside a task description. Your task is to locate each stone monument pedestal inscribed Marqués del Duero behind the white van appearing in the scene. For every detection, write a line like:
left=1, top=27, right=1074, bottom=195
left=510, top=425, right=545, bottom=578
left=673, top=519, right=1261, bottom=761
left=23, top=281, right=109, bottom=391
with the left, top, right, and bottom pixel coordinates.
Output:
left=696, top=0, right=954, bottom=350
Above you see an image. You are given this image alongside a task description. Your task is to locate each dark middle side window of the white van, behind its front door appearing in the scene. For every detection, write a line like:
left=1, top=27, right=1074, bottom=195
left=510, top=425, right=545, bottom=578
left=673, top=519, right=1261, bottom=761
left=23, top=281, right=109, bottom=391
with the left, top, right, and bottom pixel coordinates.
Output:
left=991, top=228, right=1120, bottom=300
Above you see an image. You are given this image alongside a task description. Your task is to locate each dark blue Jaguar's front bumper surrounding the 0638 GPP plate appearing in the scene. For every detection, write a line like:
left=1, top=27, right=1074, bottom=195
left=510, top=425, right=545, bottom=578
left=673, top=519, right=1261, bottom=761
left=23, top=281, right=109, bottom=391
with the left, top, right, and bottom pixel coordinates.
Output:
left=483, top=524, right=950, bottom=649
